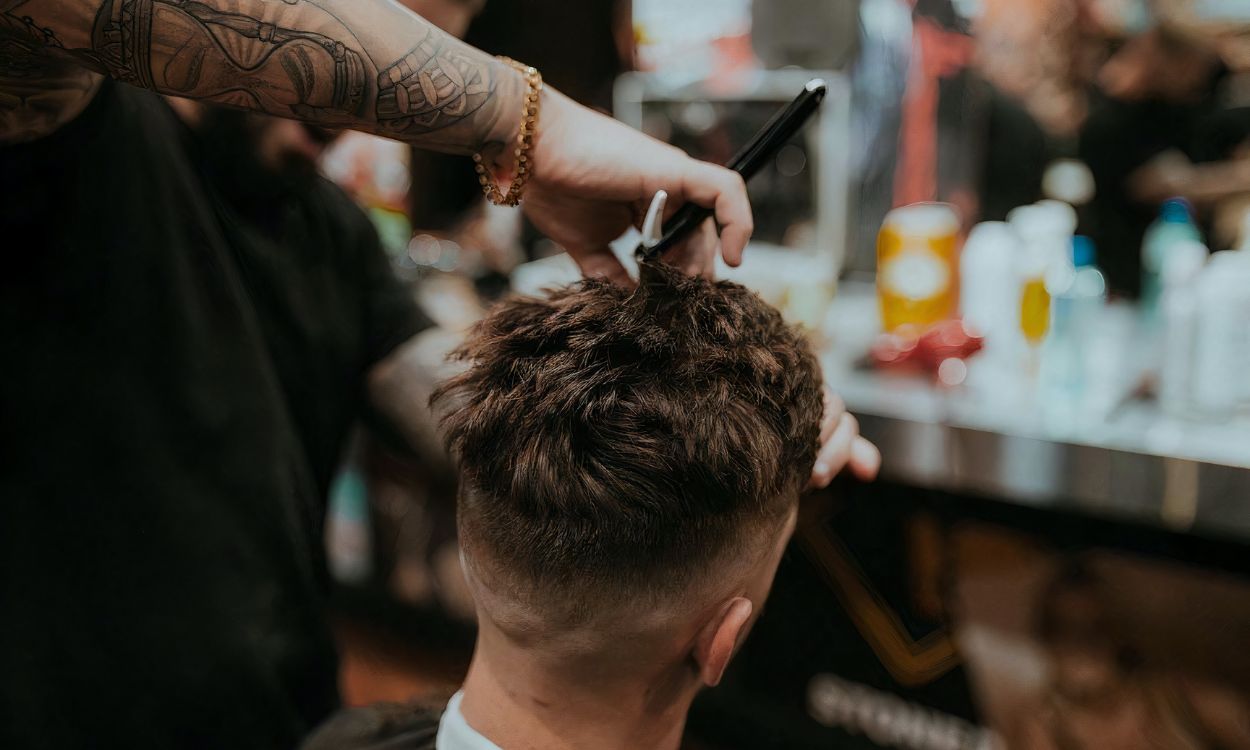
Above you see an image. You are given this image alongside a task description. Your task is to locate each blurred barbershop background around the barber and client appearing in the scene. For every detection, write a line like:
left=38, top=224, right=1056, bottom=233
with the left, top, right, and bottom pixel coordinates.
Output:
left=323, top=0, right=1250, bottom=749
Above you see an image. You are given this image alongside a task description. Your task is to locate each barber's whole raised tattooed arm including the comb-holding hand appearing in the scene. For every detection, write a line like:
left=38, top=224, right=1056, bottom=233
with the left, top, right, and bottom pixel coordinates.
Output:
left=0, top=0, right=753, bottom=278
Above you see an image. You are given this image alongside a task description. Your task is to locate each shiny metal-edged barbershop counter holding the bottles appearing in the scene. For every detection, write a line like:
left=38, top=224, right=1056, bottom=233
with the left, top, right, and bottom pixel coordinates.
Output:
left=823, top=281, right=1250, bottom=543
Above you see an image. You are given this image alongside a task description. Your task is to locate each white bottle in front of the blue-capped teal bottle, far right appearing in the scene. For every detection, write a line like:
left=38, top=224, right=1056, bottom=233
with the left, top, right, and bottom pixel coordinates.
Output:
left=1159, top=241, right=1208, bottom=416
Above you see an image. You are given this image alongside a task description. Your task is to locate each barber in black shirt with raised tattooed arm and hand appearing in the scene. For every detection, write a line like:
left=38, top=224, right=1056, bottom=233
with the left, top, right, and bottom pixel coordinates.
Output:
left=0, top=0, right=751, bottom=749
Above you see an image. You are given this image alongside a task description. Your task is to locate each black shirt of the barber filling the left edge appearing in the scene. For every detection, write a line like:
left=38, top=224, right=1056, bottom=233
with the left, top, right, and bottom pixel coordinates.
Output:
left=0, top=81, right=419, bottom=749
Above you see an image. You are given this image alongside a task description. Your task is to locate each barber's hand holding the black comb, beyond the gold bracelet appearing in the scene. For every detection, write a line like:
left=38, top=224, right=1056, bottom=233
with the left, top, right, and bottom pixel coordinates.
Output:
left=523, top=89, right=753, bottom=284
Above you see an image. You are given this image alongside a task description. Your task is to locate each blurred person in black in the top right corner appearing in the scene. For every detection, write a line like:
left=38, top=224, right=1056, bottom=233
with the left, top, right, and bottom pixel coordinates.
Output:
left=1045, top=0, right=1250, bottom=295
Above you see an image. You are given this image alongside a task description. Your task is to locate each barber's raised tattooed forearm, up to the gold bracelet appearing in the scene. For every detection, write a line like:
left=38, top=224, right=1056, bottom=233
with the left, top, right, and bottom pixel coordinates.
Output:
left=0, top=0, right=524, bottom=154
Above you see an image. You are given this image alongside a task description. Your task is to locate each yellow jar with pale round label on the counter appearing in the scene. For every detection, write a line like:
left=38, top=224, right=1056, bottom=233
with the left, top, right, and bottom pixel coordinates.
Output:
left=876, top=203, right=959, bottom=331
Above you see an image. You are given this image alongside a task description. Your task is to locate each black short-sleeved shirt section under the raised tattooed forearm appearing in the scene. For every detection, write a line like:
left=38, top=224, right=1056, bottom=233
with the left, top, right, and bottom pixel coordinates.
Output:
left=185, top=111, right=433, bottom=496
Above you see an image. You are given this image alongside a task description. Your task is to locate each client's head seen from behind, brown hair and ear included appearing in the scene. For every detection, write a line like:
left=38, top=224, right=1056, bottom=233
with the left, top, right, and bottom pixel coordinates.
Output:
left=435, top=265, right=821, bottom=684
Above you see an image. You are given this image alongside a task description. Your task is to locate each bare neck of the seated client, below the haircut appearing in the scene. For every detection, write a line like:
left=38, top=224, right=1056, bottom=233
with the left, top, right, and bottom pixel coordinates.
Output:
left=460, top=631, right=696, bottom=750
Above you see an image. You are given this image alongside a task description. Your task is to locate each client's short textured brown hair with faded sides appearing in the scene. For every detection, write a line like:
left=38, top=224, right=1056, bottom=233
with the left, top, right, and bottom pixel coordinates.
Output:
left=434, top=264, right=823, bottom=617
